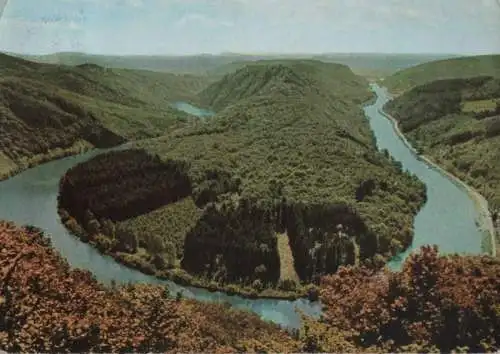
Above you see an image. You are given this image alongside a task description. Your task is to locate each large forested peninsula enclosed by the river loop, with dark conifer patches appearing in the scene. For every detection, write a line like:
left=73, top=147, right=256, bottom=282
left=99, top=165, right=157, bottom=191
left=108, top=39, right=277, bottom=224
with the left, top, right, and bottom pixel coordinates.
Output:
left=59, top=60, right=425, bottom=296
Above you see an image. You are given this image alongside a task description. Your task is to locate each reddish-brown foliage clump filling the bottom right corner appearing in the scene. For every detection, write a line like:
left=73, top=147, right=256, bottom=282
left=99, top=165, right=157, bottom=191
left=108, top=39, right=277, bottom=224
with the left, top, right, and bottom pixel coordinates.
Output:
left=302, top=246, right=500, bottom=353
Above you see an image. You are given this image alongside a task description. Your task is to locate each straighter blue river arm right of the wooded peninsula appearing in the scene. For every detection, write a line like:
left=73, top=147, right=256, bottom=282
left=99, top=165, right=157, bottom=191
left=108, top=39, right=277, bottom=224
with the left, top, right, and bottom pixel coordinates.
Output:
left=365, top=84, right=483, bottom=269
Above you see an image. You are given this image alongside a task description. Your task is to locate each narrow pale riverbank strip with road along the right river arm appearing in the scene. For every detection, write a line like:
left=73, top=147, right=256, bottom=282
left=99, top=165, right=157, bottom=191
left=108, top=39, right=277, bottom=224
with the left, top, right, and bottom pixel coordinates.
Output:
left=378, top=108, right=497, bottom=257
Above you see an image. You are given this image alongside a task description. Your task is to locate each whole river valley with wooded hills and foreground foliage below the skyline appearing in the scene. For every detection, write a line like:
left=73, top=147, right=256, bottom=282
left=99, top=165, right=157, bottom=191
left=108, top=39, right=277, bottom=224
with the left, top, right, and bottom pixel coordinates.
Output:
left=0, top=49, right=500, bottom=352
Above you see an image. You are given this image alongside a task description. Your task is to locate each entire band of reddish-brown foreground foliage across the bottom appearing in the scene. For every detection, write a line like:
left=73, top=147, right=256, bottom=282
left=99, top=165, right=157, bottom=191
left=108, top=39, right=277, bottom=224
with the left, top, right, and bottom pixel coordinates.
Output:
left=0, top=222, right=500, bottom=353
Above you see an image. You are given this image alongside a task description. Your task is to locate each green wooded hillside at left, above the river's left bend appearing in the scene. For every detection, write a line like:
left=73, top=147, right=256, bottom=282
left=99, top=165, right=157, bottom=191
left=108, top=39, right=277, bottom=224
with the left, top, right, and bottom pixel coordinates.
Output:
left=0, top=54, right=206, bottom=180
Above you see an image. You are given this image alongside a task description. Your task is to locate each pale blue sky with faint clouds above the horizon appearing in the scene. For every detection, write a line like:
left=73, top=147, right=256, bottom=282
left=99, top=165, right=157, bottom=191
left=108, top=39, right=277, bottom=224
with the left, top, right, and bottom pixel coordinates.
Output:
left=0, top=0, right=500, bottom=55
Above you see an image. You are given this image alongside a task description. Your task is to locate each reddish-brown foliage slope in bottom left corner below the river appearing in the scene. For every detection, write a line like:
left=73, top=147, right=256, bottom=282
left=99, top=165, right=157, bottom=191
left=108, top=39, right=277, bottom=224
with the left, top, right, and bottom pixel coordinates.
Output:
left=0, top=222, right=299, bottom=353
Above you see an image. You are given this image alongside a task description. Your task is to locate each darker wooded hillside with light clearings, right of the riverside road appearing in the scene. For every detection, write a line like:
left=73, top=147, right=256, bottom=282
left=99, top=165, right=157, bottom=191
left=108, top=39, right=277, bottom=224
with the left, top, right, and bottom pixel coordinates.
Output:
left=385, top=77, right=500, bottom=211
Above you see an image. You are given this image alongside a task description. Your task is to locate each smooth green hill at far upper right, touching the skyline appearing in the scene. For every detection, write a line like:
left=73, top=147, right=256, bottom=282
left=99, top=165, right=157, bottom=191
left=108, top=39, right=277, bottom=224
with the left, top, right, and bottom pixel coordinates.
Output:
left=383, top=55, right=500, bottom=92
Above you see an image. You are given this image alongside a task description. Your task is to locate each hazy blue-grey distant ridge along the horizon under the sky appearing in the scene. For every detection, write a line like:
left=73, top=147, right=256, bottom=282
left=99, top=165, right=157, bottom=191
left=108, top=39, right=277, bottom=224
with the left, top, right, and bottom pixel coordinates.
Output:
left=12, top=52, right=457, bottom=77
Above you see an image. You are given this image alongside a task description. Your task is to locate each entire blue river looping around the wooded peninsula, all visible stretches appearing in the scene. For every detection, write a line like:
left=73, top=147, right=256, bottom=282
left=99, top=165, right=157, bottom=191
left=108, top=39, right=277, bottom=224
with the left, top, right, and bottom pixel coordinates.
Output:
left=0, top=85, right=481, bottom=328
